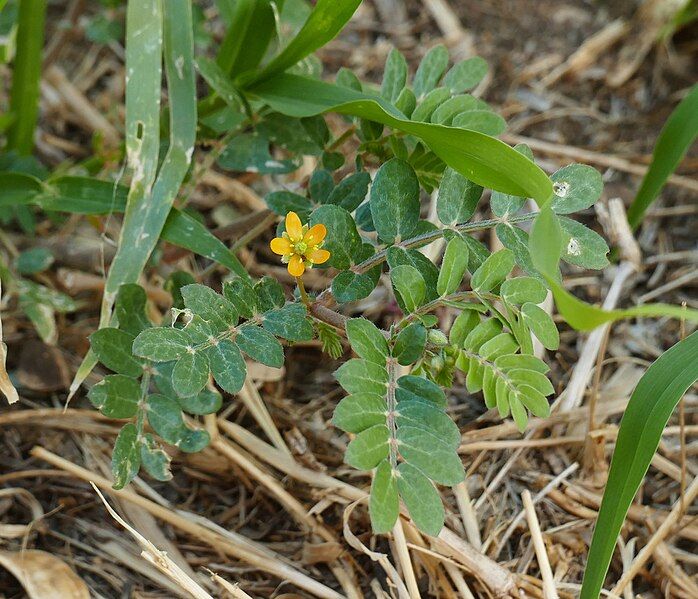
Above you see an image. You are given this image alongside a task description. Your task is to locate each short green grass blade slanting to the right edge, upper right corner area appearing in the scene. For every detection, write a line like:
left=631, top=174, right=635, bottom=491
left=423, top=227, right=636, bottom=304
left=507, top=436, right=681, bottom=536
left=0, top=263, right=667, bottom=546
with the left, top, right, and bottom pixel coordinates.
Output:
left=628, top=84, right=698, bottom=229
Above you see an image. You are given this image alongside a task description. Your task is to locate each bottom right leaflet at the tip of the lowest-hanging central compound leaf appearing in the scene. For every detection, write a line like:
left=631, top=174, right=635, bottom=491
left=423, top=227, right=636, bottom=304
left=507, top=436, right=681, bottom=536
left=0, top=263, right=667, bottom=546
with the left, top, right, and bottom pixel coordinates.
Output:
left=397, top=462, right=445, bottom=536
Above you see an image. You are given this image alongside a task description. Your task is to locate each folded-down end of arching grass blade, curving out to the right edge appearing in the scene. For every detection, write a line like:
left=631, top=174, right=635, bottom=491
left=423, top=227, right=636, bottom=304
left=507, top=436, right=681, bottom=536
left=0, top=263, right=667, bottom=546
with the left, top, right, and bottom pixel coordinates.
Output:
left=529, top=206, right=698, bottom=331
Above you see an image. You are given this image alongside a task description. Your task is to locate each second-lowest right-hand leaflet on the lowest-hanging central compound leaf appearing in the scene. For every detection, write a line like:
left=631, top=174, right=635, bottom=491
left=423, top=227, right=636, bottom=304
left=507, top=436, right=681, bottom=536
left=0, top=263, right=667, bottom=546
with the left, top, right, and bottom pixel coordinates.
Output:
left=397, top=426, right=465, bottom=486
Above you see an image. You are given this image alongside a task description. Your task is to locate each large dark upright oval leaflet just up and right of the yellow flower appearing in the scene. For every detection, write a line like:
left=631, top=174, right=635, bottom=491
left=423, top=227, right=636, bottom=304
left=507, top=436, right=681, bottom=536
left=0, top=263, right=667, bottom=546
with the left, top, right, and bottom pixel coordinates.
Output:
left=369, top=158, right=419, bottom=243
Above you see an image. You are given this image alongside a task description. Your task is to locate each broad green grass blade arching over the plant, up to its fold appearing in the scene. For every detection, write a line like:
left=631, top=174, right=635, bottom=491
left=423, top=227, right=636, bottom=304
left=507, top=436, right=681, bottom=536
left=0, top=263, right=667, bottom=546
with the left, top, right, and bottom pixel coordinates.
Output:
left=246, top=74, right=553, bottom=204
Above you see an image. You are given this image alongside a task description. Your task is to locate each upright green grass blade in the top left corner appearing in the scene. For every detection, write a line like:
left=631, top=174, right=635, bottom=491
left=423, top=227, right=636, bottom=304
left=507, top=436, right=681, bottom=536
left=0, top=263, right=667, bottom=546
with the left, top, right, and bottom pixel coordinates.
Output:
left=7, top=0, right=47, bottom=155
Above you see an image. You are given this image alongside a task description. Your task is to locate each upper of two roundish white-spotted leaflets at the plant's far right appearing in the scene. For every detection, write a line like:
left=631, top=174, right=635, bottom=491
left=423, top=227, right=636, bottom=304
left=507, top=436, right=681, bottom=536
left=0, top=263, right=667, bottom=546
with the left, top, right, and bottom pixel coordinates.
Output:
left=550, top=164, right=603, bottom=214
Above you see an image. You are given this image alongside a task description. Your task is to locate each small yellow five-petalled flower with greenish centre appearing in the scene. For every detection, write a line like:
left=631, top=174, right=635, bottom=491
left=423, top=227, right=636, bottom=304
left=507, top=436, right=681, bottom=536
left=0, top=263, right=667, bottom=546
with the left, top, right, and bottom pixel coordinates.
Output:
left=269, top=212, right=330, bottom=277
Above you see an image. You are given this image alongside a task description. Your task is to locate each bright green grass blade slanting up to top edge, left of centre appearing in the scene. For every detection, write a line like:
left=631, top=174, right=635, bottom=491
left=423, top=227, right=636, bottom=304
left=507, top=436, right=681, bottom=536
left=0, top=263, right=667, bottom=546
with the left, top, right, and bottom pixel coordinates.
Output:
left=247, top=0, right=361, bottom=82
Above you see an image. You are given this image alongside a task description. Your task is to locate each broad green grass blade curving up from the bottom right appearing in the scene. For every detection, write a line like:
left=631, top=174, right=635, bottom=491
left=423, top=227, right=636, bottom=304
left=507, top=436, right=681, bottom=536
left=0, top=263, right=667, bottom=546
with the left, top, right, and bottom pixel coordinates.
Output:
left=580, top=332, right=698, bottom=599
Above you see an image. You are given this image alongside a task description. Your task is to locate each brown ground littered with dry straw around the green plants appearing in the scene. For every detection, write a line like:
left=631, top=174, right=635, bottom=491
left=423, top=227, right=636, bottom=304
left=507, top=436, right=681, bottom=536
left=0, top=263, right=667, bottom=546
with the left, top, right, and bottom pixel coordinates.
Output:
left=0, top=0, right=698, bottom=599
